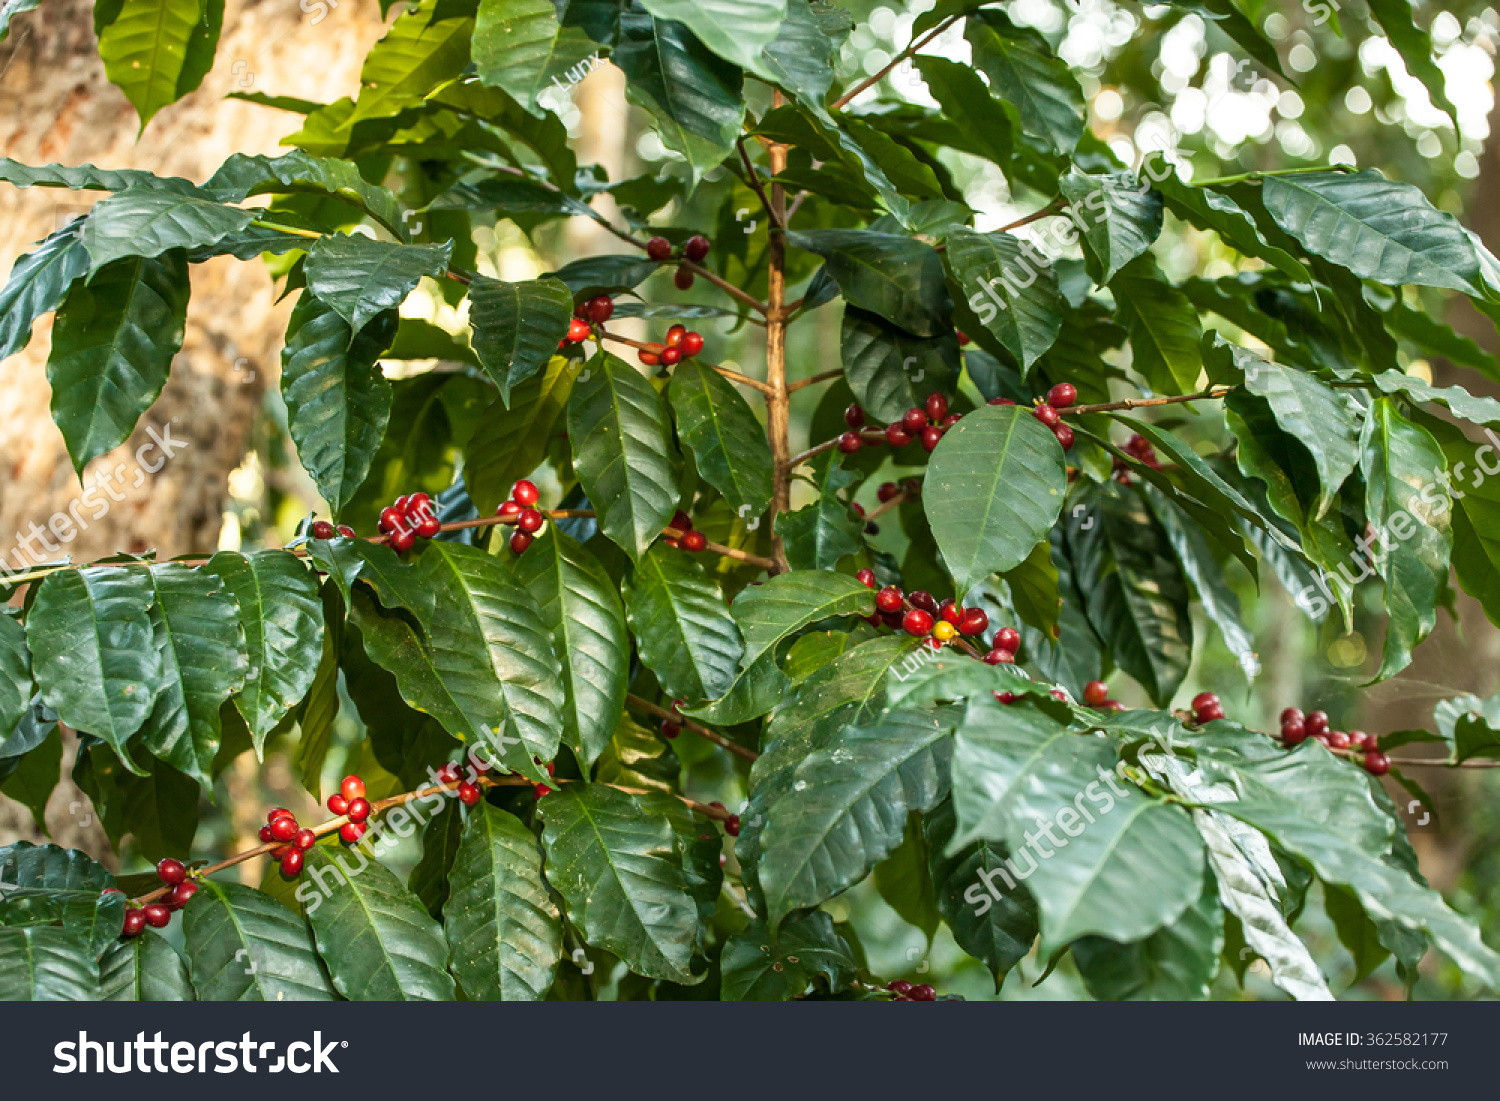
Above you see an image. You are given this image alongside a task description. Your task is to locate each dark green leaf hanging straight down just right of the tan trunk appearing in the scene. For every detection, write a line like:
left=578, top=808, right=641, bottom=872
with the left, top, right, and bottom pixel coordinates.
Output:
left=281, top=294, right=396, bottom=515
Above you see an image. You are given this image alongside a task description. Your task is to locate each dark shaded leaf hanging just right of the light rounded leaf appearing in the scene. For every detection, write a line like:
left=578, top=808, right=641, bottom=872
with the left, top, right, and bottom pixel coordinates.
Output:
left=1067, top=486, right=1193, bottom=707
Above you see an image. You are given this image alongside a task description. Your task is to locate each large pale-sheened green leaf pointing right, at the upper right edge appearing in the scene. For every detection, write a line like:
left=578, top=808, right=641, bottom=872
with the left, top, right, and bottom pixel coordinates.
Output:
left=1262, top=168, right=1484, bottom=296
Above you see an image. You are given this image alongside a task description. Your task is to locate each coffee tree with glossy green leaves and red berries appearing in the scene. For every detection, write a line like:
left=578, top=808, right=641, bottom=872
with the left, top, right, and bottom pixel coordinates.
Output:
left=0, top=0, right=1500, bottom=1001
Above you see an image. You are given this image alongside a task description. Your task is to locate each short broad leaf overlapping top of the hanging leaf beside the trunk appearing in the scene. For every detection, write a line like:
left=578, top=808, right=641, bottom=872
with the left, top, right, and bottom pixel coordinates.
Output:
left=306, top=234, right=453, bottom=334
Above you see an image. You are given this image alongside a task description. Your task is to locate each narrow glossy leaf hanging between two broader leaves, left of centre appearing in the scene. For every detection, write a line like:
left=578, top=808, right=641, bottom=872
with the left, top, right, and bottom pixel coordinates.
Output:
left=513, top=524, right=630, bottom=770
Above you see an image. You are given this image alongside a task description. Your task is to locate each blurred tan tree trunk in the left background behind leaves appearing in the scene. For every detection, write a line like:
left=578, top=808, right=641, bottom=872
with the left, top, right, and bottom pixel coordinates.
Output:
left=0, top=0, right=383, bottom=857
